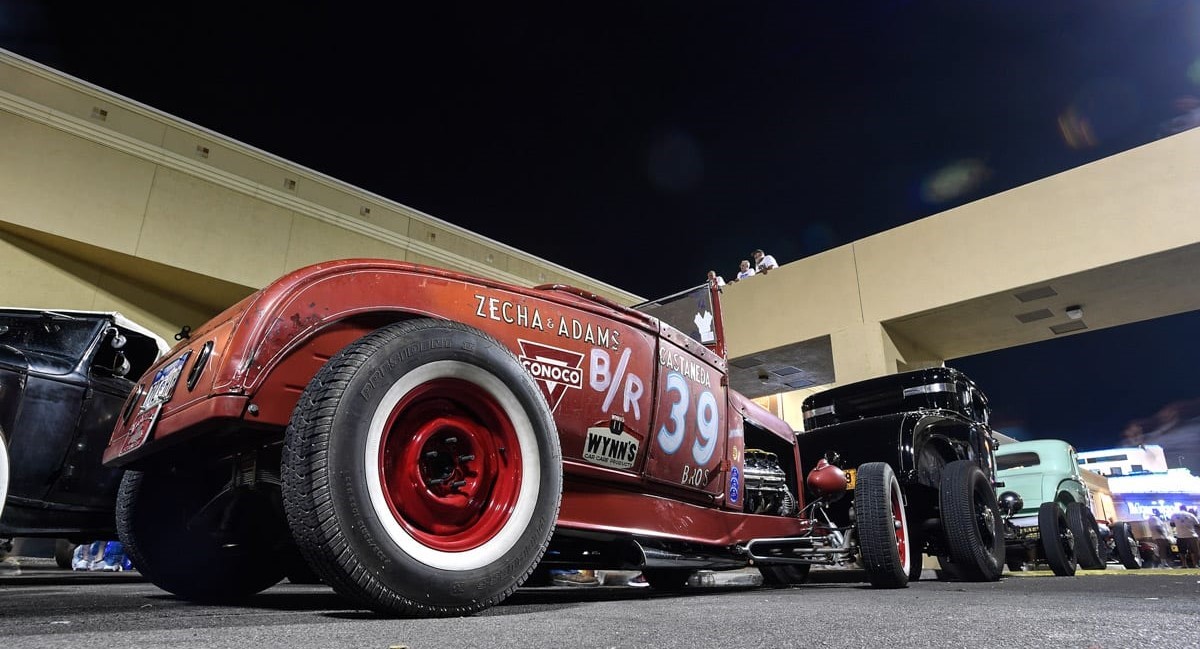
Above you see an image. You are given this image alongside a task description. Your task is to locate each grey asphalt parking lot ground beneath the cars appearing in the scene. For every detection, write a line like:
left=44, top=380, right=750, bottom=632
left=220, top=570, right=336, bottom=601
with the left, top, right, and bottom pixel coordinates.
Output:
left=0, top=560, right=1200, bottom=649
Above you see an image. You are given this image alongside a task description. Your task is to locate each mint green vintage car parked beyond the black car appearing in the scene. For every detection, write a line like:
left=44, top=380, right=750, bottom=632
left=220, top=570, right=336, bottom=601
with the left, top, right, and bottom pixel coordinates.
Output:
left=996, top=439, right=1109, bottom=576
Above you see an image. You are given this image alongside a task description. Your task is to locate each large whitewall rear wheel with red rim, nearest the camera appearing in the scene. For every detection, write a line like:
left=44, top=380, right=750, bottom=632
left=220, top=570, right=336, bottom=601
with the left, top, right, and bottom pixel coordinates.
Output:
left=282, top=319, right=563, bottom=615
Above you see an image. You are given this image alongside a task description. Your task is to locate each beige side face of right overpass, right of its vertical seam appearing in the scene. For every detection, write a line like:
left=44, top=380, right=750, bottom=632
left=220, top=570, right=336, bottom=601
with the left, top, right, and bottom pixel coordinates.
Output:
left=854, top=130, right=1200, bottom=322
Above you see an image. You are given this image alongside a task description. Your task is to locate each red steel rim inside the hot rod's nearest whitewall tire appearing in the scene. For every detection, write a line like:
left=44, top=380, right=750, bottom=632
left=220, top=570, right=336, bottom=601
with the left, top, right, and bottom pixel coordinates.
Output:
left=379, top=378, right=522, bottom=552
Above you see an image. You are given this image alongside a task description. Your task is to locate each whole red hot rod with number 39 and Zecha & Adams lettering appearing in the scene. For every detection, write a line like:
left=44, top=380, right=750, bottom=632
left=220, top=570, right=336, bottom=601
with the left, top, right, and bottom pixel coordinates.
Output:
left=104, top=259, right=914, bottom=615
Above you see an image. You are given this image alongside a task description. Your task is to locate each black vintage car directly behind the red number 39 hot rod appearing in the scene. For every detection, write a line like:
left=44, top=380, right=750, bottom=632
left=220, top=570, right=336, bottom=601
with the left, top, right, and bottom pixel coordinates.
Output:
left=797, top=367, right=1004, bottom=581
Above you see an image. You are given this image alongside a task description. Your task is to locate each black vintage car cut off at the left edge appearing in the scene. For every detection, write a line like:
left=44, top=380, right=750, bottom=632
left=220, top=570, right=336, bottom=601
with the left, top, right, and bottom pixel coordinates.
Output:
left=0, top=307, right=167, bottom=542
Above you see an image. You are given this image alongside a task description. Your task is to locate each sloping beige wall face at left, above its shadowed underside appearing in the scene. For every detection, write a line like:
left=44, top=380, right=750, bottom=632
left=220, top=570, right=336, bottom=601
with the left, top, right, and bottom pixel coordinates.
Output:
left=0, top=50, right=642, bottom=308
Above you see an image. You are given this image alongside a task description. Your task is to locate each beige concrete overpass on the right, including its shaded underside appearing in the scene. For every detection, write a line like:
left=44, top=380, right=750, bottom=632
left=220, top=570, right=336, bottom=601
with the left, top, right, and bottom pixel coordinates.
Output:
left=724, top=130, right=1200, bottom=425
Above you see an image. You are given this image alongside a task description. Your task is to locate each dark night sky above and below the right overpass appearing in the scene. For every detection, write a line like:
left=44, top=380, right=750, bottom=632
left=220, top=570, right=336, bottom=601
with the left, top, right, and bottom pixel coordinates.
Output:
left=0, top=0, right=1200, bottom=450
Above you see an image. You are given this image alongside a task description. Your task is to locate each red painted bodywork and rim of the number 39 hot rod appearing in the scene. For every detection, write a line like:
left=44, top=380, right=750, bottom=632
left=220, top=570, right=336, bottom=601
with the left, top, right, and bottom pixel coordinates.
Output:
left=104, top=259, right=808, bottom=549
